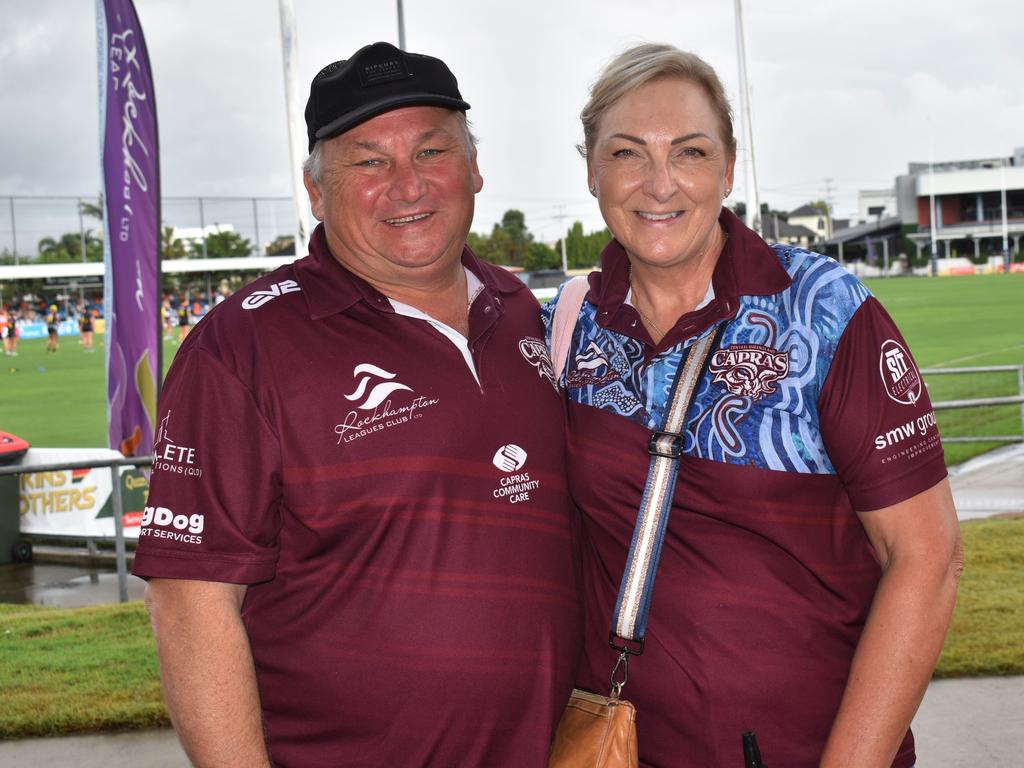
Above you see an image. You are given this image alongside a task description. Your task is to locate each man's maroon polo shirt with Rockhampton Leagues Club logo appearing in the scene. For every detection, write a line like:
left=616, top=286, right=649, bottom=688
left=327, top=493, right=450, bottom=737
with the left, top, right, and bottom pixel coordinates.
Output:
left=134, top=227, right=580, bottom=766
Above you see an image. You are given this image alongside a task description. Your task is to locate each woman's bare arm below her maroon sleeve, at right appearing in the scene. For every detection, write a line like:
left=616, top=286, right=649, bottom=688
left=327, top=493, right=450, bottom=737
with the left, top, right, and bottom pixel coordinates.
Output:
left=821, top=480, right=964, bottom=768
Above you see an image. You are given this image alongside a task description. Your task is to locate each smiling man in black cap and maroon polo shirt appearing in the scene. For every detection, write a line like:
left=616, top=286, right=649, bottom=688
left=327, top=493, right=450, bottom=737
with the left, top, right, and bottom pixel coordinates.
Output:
left=134, top=43, right=579, bottom=766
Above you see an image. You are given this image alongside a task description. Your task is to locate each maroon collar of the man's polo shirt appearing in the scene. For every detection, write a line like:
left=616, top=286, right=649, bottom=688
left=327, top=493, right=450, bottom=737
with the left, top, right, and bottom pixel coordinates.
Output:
left=294, top=223, right=526, bottom=319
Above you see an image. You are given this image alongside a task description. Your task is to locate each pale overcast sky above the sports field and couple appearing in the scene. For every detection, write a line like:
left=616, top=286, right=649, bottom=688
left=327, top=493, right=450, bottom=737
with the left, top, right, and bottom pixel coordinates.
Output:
left=0, top=0, right=1024, bottom=246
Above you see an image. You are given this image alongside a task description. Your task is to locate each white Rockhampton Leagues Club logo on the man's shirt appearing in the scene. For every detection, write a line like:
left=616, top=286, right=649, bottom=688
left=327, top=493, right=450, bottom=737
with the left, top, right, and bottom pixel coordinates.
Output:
left=334, top=362, right=440, bottom=445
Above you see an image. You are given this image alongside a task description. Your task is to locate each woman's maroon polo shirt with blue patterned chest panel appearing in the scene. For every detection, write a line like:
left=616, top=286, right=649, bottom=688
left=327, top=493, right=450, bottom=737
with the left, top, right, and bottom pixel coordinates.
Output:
left=545, top=212, right=946, bottom=768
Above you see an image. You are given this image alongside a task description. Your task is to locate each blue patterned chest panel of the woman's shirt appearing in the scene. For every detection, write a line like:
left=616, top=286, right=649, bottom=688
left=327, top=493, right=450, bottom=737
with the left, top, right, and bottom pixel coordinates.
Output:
left=544, top=246, right=870, bottom=474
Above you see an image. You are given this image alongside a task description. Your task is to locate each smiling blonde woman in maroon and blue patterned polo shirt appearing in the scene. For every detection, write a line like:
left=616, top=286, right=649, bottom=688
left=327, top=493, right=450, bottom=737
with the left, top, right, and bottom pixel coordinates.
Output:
left=545, top=45, right=962, bottom=768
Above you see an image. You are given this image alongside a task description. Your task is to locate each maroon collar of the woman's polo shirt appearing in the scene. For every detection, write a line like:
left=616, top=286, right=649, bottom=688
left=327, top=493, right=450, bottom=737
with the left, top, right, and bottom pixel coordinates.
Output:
left=588, top=208, right=793, bottom=347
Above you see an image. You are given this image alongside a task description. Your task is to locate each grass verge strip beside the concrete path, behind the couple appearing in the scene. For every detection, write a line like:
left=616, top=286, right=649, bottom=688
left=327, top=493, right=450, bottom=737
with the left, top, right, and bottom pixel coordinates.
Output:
left=0, top=518, right=1024, bottom=738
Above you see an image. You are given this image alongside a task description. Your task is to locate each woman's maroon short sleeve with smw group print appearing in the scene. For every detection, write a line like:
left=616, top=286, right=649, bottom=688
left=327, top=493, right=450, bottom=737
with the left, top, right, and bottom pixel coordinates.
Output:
left=818, top=297, right=946, bottom=511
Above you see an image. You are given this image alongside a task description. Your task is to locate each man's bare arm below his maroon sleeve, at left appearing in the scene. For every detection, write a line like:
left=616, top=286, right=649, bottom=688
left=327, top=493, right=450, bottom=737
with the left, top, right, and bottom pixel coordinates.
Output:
left=145, top=579, right=270, bottom=768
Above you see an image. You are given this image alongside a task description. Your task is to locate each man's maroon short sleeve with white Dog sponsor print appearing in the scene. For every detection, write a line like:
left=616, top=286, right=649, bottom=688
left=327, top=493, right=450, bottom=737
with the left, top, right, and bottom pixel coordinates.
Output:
left=133, top=345, right=282, bottom=584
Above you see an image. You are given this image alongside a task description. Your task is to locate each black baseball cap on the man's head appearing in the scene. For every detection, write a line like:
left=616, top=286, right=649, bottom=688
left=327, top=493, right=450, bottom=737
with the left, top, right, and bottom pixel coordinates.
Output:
left=306, top=43, right=469, bottom=152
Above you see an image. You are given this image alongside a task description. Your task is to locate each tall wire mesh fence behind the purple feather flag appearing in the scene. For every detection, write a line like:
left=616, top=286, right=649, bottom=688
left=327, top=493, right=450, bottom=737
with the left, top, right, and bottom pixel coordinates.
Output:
left=0, top=196, right=295, bottom=264
